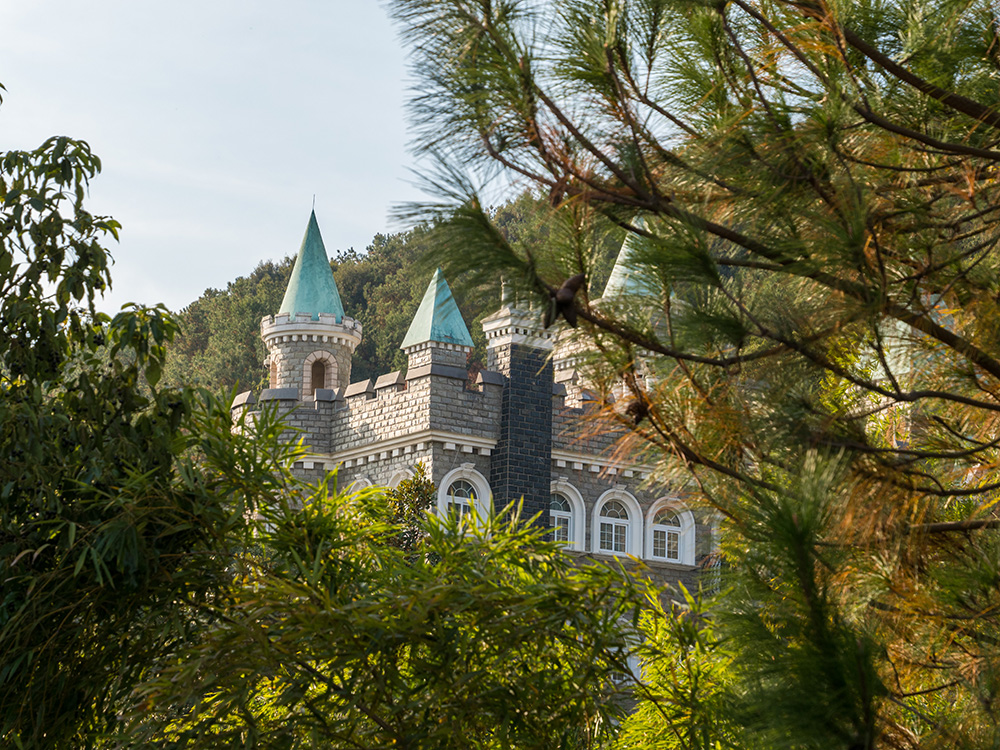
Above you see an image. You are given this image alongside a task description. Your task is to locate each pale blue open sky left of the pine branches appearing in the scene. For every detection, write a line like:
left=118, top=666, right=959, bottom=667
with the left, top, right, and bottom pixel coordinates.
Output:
left=0, top=0, right=423, bottom=312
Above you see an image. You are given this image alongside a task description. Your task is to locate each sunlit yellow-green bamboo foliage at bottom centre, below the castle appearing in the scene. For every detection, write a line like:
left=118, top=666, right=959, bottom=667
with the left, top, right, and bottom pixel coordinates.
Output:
left=130, top=487, right=642, bottom=748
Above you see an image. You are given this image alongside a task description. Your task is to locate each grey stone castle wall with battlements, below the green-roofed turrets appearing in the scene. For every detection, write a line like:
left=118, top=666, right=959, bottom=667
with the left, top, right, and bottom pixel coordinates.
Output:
left=234, top=308, right=713, bottom=588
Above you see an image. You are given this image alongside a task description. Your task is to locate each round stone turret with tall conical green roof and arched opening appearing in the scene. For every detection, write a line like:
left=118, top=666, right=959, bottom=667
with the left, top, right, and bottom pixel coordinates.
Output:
left=260, top=212, right=361, bottom=400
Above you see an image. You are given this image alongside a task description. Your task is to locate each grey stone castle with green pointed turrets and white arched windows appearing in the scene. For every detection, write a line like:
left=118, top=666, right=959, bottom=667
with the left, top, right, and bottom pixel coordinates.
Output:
left=232, top=213, right=712, bottom=585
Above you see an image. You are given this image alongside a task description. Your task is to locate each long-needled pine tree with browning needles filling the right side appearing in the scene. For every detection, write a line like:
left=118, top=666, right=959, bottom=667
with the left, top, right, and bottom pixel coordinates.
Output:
left=390, top=0, right=1000, bottom=748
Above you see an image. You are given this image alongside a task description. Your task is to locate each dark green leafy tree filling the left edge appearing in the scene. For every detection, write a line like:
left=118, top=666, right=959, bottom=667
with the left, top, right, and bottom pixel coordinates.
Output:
left=0, top=131, right=304, bottom=747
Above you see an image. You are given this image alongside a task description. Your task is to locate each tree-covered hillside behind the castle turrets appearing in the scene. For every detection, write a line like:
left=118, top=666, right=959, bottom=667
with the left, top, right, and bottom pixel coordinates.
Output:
left=164, top=192, right=622, bottom=391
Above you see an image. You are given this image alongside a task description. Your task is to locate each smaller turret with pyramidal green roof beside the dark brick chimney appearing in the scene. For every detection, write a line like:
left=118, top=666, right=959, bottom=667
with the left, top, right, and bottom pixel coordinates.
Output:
left=399, top=268, right=474, bottom=371
